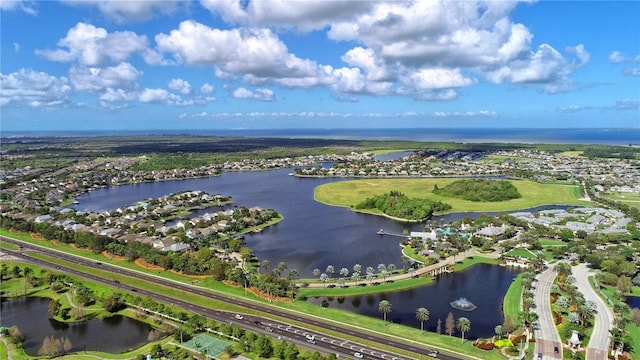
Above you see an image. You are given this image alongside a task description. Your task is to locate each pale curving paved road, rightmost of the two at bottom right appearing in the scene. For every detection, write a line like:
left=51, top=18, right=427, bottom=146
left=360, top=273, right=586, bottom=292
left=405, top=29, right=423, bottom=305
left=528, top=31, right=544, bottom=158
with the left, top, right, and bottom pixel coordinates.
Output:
left=571, top=264, right=613, bottom=360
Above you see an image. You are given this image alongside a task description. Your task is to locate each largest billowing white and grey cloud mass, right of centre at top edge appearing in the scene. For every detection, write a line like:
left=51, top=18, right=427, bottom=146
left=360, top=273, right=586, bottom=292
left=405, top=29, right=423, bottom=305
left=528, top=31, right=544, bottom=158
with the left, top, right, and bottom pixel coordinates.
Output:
left=328, top=1, right=590, bottom=94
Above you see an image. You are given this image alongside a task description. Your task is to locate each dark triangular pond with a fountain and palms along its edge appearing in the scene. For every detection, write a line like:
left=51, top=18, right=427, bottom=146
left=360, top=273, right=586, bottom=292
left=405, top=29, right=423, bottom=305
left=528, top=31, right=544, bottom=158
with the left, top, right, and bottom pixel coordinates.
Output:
left=308, top=264, right=519, bottom=338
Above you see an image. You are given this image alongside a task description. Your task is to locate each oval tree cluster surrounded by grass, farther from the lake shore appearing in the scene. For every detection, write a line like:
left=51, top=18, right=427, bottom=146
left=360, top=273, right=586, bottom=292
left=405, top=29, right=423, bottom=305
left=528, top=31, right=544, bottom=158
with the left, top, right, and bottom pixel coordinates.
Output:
left=433, top=179, right=522, bottom=202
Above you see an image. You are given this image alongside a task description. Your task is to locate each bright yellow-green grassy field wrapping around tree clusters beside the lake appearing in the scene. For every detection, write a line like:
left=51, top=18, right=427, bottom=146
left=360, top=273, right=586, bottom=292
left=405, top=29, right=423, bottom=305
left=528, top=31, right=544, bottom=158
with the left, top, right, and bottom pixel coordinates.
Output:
left=315, top=178, right=589, bottom=212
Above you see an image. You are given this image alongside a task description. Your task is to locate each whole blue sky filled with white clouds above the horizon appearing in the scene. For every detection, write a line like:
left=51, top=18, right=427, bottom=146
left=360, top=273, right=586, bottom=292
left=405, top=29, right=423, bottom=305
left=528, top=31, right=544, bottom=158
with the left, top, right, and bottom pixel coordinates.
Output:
left=0, top=0, right=640, bottom=131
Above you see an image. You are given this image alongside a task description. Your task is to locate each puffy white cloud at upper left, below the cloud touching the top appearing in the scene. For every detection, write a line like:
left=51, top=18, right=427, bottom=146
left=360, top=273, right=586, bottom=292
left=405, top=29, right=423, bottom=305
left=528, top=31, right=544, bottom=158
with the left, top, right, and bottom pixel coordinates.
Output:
left=36, top=22, right=148, bottom=66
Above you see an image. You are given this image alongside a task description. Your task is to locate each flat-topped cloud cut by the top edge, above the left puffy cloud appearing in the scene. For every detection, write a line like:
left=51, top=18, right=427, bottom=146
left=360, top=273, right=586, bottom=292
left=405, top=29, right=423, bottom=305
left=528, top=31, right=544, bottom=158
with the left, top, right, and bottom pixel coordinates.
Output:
left=63, top=0, right=184, bottom=23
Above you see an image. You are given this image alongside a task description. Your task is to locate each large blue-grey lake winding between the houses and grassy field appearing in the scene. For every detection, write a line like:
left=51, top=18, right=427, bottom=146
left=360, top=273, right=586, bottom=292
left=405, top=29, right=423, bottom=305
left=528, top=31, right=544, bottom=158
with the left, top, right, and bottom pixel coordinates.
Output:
left=76, top=161, right=557, bottom=277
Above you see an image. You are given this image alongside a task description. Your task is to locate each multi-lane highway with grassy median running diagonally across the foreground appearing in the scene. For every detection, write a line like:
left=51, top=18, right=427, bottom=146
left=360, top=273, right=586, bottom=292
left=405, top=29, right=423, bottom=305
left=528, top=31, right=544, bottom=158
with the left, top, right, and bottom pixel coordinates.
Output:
left=0, top=237, right=472, bottom=360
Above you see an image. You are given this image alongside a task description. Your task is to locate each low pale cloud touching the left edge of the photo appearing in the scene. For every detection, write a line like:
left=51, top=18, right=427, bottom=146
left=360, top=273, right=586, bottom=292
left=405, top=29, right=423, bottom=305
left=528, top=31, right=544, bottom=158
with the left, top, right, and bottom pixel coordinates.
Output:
left=0, top=69, right=73, bottom=107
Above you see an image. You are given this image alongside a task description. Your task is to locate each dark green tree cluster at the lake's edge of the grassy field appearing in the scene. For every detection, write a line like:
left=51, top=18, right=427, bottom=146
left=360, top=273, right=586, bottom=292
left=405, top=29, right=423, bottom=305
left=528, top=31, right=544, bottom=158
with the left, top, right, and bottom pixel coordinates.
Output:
left=354, top=191, right=451, bottom=220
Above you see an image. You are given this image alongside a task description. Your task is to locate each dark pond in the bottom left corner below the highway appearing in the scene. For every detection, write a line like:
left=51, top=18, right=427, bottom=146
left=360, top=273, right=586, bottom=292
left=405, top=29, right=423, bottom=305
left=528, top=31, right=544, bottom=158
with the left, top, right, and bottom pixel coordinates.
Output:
left=0, top=297, right=157, bottom=356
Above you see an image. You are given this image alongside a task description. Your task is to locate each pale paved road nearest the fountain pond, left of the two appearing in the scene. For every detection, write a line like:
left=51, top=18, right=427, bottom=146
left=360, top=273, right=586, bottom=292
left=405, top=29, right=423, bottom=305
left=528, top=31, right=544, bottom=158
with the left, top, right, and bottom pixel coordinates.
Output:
left=533, top=267, right=562, bottom=360
